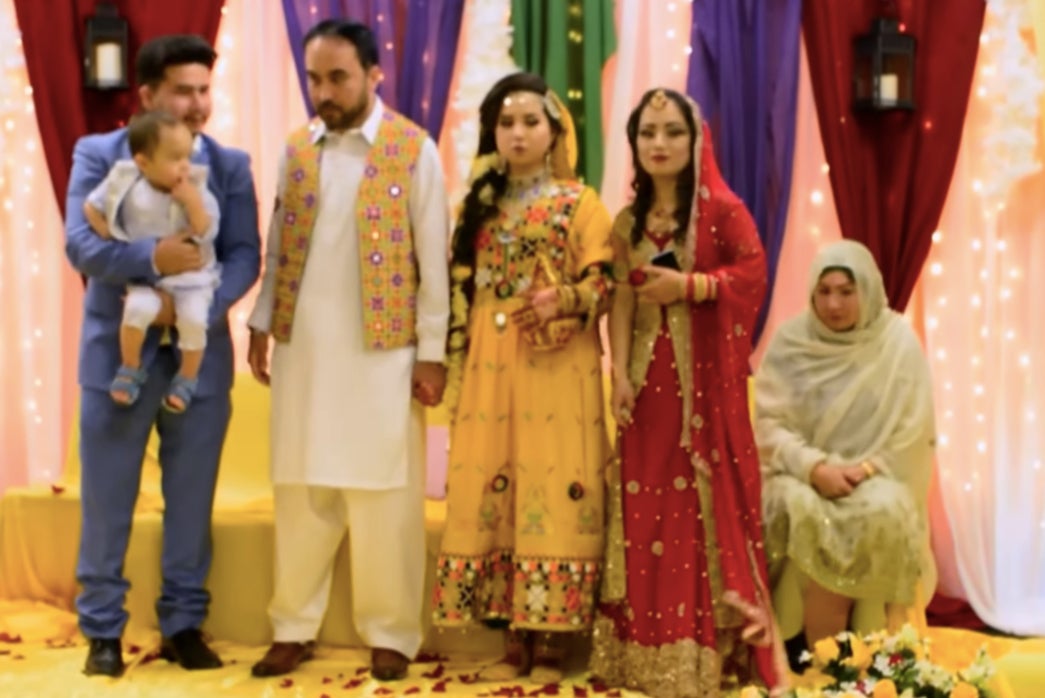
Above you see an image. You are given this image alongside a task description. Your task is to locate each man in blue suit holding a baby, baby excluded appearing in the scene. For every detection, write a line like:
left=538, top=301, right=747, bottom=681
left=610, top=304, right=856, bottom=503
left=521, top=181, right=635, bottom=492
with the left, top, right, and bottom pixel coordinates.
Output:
left=66, top=36, right=260, bottom=676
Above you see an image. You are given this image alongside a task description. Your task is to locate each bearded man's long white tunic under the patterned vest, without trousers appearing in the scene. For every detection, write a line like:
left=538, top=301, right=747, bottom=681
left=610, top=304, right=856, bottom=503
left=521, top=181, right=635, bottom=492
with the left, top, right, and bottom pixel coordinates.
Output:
left=250, top=100, right=449, bottom=490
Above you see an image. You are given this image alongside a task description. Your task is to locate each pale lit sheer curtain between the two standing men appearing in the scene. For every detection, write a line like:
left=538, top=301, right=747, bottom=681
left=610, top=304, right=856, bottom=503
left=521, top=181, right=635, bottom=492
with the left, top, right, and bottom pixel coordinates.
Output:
left=207, top=0, right=307, bottom=371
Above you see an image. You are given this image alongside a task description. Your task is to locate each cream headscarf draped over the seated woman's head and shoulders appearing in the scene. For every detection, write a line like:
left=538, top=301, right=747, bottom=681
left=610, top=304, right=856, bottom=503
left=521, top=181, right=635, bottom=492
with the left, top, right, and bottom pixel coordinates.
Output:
left=756, top=240, right=935, bottom=501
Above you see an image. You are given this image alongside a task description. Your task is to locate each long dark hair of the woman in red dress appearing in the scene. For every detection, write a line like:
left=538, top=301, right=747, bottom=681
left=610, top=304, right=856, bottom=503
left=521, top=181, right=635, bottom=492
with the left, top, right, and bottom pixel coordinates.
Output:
left=627, top=88, right=700, bottom=245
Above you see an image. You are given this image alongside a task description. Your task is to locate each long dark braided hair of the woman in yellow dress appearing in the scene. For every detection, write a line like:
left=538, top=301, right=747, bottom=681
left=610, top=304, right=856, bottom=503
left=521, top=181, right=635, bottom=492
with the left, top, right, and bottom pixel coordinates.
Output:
left=450, top=73, right=562, bottom=301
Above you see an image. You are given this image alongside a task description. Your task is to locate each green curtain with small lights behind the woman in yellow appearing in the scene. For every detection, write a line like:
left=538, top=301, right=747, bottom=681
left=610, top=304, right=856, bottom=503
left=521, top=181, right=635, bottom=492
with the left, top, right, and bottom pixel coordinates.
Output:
left=512, top=0, right=617, bottom=188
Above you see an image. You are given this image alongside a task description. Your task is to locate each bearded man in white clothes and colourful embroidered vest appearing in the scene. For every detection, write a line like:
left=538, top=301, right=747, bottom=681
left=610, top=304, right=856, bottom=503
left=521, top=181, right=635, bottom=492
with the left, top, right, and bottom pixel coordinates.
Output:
left=249, top=20, right=449, bottom=680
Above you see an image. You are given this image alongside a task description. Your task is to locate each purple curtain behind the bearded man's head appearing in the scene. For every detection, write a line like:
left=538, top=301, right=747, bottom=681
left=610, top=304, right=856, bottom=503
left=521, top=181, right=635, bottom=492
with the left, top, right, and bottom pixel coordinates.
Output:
left=283, top=0, right=465, bottom=138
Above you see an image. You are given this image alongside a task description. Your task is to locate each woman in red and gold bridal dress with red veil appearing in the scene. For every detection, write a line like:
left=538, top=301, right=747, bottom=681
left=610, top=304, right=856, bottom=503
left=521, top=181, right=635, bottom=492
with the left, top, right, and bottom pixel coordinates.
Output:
left=591, top=89, right=787, bottom=698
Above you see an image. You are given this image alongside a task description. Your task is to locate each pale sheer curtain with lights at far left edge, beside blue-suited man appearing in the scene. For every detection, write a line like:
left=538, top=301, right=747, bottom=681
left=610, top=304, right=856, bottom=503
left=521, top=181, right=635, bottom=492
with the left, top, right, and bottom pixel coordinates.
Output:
left=0, top=0, right=83, bottom=493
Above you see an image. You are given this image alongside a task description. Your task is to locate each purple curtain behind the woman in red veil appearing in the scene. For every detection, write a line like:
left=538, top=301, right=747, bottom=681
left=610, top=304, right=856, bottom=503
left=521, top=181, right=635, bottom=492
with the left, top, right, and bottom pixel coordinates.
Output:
left=687, top=0, right=802, bottom=342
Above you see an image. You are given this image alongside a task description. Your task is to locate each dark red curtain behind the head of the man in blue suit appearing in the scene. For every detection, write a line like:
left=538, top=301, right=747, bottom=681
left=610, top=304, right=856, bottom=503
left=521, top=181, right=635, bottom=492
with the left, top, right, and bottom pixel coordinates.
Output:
left=15, top=0, right=225, bottom=215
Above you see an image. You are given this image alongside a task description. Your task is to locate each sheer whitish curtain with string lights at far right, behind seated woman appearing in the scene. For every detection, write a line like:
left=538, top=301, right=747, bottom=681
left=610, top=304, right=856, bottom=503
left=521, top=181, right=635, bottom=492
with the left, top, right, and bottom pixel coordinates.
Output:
left=921, top=2, right=1045, bottom=634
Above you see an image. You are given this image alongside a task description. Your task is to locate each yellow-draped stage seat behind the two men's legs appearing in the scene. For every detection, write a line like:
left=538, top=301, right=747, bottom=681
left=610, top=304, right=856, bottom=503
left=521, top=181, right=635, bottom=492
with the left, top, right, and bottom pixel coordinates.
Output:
left=0, top=375, right=498, bottom=656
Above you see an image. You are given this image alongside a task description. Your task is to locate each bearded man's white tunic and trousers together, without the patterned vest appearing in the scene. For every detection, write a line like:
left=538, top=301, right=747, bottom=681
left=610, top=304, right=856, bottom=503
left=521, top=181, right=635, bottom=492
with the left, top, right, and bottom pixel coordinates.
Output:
left=250, top=100, right=449, bottom=657
